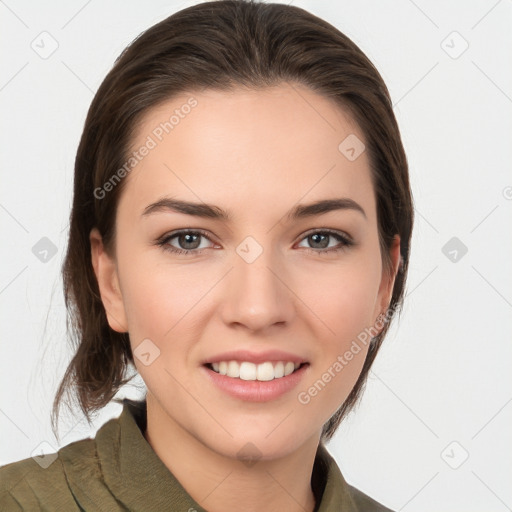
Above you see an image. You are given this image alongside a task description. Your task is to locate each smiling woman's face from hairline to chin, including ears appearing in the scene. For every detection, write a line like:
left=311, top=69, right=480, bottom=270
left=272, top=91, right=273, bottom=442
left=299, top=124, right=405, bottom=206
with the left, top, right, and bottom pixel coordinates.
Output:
left=92, top=84, right=399, bottom=458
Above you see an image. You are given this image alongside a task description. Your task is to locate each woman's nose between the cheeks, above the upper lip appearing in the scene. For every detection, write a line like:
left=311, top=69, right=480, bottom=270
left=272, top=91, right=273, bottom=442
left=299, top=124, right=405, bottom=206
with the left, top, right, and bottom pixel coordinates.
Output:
left=220, top=243, right=295, bottom=332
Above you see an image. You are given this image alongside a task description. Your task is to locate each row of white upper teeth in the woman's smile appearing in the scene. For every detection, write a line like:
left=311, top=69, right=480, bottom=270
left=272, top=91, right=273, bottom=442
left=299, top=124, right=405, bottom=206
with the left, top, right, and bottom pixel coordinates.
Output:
left=212, top=361, right=300, bottom=381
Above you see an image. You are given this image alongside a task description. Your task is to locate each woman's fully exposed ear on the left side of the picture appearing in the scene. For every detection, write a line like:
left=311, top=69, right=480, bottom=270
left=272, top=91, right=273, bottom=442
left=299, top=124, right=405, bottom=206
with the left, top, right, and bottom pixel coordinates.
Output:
left=89, top=228, right=128, bottom=332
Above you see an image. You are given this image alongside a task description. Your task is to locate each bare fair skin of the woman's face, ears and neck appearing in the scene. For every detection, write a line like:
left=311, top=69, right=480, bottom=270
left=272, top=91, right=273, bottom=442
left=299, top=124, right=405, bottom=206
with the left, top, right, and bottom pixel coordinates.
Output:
left=90, top=83, right=399, bottom=512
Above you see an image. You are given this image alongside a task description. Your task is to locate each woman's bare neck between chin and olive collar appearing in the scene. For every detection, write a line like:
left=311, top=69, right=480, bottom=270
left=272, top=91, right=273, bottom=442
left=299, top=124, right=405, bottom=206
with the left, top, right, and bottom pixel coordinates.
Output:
left=145, top=393, right=318, bottom=512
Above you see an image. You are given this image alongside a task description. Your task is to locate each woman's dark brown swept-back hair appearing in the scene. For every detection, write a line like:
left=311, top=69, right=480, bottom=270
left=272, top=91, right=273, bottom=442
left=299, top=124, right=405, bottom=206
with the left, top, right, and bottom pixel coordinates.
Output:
left=52, top=0, right=413, bottom=440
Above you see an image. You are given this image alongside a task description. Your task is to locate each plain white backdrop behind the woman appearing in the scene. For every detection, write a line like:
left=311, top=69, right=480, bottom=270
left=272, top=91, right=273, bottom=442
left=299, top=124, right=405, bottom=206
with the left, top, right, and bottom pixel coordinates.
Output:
left=0, top=0, right=512, bottom=512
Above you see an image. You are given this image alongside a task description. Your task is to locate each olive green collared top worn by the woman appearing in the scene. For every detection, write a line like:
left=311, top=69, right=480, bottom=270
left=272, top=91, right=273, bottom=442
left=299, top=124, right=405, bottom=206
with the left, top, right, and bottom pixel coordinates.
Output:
left=0, top=399, right=390, bottom=512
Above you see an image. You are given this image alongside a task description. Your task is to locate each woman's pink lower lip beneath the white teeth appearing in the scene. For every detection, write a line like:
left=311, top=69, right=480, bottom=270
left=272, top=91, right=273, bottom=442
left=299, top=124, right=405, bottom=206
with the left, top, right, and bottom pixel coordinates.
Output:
left=202, top=364, right=309, bottom=402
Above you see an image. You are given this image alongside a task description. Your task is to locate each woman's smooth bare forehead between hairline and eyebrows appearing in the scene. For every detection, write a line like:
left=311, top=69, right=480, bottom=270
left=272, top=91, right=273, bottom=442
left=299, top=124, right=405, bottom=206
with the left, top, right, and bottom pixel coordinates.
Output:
left=120, top=84, right=374, bottom=222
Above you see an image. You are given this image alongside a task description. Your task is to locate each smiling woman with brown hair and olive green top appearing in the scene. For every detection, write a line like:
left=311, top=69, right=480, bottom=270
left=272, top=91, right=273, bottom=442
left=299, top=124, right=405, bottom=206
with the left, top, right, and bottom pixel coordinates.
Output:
left=0, top=0, right=413, bottom=512
